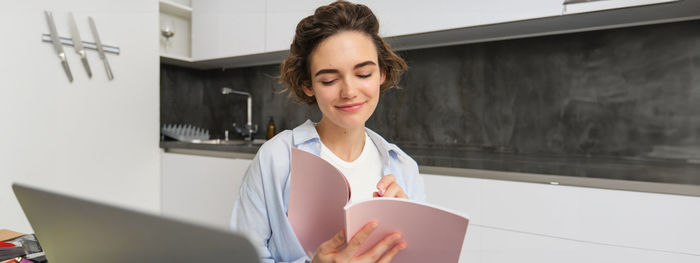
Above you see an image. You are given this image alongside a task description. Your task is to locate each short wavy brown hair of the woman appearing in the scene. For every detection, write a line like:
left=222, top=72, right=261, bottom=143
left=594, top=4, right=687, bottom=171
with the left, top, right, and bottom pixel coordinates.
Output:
left=280, top=1, right=408, bottom=105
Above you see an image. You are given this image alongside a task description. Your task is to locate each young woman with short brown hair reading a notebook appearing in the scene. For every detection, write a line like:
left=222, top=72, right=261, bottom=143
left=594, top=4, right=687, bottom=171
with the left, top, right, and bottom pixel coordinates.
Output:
left=231, top=1, right=425, bottom=262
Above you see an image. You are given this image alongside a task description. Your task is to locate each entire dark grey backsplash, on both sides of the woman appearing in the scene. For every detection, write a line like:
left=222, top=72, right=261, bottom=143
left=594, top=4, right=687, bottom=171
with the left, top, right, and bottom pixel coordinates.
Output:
left=161, top=20, right=700, bottom=182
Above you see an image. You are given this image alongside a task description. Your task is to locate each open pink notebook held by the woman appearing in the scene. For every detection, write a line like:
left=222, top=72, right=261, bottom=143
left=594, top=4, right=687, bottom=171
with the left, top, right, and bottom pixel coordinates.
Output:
left=287, top=148, right=469, bottom=263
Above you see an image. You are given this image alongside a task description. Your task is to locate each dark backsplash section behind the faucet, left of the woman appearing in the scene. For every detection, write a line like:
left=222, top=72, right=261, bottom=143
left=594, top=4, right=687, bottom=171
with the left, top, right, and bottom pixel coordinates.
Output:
left=160, top=65, right=321, bottom=139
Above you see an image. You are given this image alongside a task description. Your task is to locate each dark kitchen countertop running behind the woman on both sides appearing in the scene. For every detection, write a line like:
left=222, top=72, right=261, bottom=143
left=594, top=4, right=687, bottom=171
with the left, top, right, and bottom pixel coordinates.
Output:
left=160, top=141, right=700, bottom=196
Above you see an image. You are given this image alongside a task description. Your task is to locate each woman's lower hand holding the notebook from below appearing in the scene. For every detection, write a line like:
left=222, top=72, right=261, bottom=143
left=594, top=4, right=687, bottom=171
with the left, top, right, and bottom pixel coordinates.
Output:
left=311, top=221, right=406, bottom=263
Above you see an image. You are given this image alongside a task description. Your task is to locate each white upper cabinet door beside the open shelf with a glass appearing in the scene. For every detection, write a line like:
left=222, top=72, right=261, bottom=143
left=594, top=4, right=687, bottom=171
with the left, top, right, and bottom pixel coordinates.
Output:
left=192, top=0, right=265, bottom=60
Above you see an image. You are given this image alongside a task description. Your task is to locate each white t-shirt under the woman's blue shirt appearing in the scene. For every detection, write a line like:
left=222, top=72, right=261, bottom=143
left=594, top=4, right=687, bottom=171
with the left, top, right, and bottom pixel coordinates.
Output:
left=321, top=133, right=382, bottom=203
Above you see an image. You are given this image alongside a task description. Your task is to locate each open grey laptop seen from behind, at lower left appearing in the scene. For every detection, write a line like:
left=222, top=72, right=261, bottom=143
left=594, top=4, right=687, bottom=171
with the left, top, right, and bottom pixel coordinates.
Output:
left=12, top=184, right=260, bottom=263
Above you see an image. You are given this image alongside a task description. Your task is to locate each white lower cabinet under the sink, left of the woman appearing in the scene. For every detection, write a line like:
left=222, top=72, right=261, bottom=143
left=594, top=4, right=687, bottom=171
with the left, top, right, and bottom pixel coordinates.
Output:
left=161, top=153, right=251, bottom=229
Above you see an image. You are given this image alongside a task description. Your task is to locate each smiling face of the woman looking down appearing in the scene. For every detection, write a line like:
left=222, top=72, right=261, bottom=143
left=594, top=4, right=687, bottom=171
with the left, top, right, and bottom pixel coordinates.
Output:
left=304, top=31, right=385, bottom=129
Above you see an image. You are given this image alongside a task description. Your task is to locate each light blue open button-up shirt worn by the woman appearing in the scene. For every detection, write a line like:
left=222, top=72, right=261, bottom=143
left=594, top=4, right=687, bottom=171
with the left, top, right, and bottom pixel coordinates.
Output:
left=231, top=120, right=425, bottom=263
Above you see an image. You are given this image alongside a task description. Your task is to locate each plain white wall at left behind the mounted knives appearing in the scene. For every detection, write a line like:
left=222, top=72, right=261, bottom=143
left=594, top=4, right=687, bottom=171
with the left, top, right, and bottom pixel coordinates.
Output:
left=0, top=0, right=160, bottom=232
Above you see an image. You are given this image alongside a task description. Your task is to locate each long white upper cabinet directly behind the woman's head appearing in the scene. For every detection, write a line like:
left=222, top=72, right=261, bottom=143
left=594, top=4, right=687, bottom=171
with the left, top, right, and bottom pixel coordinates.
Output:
left=265, top=0, right=562, bottom=52
